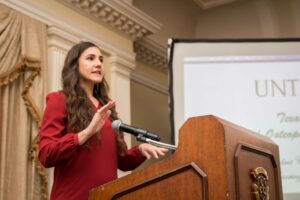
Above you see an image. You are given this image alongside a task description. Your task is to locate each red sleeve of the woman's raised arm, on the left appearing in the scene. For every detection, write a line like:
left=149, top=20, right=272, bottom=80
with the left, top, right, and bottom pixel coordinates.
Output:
left=39, top=92, right=79, bottom=167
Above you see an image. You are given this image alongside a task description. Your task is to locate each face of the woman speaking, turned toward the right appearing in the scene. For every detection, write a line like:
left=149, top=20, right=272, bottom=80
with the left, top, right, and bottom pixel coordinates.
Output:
left=78, top=47, right=104, bottom=85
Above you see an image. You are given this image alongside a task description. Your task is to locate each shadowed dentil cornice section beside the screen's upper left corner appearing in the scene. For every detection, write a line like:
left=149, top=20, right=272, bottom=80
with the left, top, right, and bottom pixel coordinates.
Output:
left=134, top=38, right=168, bottom=73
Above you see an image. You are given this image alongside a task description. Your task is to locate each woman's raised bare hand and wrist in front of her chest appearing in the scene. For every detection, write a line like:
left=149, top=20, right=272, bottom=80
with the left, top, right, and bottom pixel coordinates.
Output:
left=78, top=101, right=115, bottom=145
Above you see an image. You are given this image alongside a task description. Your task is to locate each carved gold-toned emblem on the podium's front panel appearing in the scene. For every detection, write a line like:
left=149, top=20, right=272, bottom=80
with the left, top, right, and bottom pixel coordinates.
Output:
left=250, top=167, right=270, bottom=200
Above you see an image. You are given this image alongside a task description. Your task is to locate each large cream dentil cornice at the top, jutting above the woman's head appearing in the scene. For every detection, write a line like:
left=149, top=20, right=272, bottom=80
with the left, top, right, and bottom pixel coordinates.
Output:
left=57, top=0, right=162, bottom=40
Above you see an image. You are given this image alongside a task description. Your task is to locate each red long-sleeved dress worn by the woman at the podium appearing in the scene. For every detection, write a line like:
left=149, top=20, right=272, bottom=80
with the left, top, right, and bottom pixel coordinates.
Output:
left=39, top=92, right=145, bottom=200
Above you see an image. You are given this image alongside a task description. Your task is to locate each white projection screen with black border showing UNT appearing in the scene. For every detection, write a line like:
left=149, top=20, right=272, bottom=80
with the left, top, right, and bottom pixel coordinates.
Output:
left=169, top=38, right=300, bottom=200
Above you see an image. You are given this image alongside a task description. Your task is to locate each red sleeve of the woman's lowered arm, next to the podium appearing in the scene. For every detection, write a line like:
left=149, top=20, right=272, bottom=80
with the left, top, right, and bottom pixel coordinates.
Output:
left=118, top=146, right=146, bottom=171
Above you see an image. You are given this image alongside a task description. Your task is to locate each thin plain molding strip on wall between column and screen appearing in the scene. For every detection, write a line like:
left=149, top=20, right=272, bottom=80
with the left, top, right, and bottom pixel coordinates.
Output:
left=131, top=72, right=169, bottom=95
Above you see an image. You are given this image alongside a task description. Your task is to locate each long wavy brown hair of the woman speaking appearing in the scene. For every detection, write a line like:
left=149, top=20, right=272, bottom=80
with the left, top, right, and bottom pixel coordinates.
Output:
left=62, top=42, right=126, bottom=155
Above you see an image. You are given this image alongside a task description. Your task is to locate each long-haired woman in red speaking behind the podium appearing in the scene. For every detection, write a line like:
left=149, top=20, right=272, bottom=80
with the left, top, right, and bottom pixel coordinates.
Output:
left=39, top=42, right=168, bottom=200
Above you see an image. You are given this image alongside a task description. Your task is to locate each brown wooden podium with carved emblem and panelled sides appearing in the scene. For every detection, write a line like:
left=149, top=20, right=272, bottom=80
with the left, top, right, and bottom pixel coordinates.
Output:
left=89, top=116, right=283, bottom=200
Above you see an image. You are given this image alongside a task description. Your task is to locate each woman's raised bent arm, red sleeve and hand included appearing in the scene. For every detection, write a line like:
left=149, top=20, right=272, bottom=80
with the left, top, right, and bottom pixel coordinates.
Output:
left=39, top=92, right=115, bottom=167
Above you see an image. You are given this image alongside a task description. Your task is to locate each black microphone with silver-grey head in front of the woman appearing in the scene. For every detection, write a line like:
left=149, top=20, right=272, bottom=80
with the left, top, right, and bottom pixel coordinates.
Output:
left=111, top=120, right=160, bottom=141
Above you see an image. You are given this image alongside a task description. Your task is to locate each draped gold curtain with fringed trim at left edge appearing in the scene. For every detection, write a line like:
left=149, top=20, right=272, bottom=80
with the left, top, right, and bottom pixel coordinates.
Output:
left=0, top=4, right=48, bottom=200
